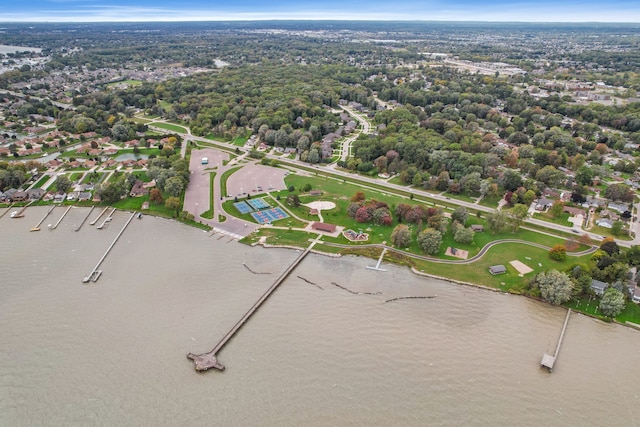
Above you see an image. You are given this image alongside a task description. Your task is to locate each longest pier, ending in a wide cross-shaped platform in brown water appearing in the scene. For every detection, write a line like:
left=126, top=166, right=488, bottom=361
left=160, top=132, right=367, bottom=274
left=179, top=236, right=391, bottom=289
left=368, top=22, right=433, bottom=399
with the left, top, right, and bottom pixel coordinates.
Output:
left=187, top=240, right=317, bottom=371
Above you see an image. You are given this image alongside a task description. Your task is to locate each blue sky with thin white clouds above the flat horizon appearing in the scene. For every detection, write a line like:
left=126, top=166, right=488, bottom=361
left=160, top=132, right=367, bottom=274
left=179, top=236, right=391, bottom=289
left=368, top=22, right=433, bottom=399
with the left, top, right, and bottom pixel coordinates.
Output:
left=0, top=0, right=640, bottom=23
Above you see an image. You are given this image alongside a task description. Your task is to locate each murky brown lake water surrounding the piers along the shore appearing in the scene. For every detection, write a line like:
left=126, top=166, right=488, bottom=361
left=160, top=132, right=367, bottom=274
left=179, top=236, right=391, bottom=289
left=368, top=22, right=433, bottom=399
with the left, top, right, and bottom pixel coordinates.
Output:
left=0, top=207, right=640, bottom=426
